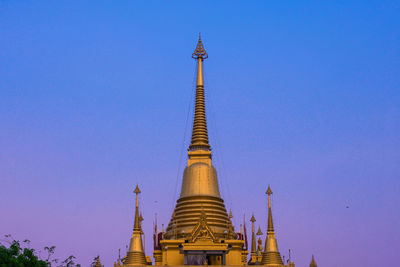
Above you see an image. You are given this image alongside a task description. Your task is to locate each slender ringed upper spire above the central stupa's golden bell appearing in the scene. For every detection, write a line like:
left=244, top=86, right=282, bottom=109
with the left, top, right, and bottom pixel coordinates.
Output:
left=189, top=34, right=211, bottom=151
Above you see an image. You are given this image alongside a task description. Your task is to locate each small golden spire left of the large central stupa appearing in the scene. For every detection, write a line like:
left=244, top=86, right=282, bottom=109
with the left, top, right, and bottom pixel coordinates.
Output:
left=123, top=185, right=146, bottom=266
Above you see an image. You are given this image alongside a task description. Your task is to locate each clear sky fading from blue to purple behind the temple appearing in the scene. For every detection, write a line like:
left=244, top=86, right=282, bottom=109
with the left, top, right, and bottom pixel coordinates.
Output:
left=0, top=0, right=400, bottom=267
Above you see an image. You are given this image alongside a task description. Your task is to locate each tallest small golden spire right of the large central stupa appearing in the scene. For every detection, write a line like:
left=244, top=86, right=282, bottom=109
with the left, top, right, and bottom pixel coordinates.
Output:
left=261, top=186, right=283, bottom=267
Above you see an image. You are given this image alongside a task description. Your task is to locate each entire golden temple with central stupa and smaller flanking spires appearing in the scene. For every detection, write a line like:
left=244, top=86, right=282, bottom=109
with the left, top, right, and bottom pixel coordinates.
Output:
left=114, top=38, right=311, bottom=267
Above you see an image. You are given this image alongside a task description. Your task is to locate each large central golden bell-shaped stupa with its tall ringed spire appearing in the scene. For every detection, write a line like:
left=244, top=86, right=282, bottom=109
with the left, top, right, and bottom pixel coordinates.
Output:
left=165, top=37, right=230, bottom=239
